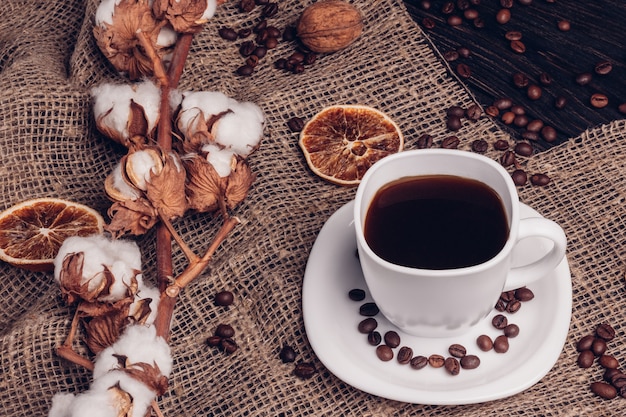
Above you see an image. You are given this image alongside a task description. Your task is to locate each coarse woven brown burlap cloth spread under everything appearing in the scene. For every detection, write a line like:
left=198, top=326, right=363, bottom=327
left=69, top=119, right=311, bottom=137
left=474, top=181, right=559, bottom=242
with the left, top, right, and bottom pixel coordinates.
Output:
left=0, top=0, right=626, bottom=417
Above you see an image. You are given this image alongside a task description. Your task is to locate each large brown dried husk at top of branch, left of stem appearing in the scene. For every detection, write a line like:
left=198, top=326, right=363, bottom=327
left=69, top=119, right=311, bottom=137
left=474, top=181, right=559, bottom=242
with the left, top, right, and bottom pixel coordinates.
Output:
left=93, top=0, right=169, bottom=80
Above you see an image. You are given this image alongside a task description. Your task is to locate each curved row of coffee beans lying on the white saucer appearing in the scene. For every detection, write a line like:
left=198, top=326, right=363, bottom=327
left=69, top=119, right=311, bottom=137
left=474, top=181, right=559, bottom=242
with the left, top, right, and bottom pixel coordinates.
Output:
left=348, top=287, right=534, bottom=376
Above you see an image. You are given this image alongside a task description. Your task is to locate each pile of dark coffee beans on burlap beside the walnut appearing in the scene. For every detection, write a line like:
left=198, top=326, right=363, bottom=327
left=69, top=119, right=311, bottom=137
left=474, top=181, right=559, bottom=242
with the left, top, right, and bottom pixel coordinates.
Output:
left=218, top=0, right=317, bottom=76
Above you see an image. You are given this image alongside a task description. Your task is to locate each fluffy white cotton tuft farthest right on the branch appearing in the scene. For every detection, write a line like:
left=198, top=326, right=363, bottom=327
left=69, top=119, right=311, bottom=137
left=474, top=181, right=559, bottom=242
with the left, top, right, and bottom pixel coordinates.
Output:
left=215, top=102, right=264, bottom=157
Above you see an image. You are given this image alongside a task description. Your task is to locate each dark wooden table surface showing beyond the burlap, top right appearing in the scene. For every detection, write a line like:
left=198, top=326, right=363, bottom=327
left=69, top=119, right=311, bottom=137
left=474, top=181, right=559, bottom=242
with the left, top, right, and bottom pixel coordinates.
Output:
left=404, top=0, right=626, bottom=149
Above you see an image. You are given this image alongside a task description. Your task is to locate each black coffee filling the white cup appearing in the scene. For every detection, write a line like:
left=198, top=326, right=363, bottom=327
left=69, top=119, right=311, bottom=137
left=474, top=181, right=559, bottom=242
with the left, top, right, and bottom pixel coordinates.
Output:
left=364, top=175, right=509, bottom=269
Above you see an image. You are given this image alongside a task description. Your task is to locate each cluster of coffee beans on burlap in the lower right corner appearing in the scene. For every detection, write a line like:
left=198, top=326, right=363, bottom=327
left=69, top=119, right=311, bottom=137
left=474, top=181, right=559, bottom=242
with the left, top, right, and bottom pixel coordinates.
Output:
left=576, top=323, right=626, bottom=400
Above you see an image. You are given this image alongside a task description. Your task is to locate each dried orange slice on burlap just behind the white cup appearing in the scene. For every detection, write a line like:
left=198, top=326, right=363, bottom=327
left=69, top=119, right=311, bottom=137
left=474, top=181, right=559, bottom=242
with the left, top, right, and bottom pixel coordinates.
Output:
left=300, top=105, right=404, bottom=186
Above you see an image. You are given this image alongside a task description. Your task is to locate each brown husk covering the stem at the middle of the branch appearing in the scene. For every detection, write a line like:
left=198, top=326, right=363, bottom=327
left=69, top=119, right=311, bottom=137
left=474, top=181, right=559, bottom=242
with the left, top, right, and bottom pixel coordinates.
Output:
left=146, top=153, right=187, bottom=219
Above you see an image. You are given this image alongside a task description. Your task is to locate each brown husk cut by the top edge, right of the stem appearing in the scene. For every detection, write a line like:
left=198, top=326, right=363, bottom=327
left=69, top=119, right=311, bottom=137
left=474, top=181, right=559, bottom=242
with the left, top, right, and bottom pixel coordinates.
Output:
left=152, top=0, right=215, bottom=33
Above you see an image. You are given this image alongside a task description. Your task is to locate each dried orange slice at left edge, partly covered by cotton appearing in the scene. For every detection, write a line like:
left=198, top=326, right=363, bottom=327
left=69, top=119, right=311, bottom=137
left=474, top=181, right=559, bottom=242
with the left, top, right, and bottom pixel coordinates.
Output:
left=0, top=198, right=104, bottom=271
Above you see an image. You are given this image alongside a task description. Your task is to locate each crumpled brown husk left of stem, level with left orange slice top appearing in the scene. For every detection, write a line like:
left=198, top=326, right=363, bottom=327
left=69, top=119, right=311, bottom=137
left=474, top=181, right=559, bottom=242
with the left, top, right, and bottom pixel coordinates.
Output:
left=104, top=198, right=159, bottom=239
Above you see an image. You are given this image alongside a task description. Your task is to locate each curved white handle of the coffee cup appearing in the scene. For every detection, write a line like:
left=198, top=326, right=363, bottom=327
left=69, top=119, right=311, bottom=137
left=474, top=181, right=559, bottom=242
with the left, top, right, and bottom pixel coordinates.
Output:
left=503, top=217, right=567, bottom=291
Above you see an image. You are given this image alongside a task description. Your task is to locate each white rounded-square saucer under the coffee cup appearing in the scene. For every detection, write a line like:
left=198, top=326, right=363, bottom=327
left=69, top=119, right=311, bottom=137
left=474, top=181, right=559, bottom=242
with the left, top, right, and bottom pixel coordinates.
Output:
left=302, top=202, right=572, bottom=405
